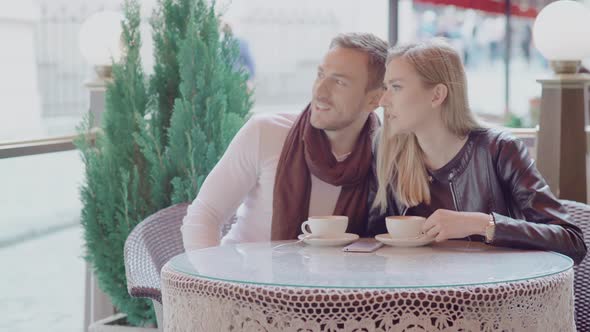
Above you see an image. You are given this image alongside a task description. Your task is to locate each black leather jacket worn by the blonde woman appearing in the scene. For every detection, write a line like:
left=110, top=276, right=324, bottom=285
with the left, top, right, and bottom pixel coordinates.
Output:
left=367, top=129, right=587, bottom=264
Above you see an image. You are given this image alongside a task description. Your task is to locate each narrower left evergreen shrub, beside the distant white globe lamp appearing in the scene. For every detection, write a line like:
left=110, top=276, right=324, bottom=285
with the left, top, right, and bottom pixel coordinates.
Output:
left=77, top=0, right=155, bottom=324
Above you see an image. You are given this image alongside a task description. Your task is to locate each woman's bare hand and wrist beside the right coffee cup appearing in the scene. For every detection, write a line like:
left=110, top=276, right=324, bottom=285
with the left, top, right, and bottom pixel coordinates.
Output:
left=422, top=209, right=490, bottom=242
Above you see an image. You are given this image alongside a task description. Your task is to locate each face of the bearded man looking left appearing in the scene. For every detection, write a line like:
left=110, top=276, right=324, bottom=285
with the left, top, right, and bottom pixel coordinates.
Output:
left=310, top=47, right=372, bottom=131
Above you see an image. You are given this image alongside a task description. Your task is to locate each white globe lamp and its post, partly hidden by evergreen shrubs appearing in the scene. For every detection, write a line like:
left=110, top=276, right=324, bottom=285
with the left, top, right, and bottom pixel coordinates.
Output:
left=78, top=11, right=123, bottom=331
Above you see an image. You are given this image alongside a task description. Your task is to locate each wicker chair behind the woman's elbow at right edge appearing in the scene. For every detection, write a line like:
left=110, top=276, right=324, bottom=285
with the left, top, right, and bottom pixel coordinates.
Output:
left=562, top=200, right=590, bottom=332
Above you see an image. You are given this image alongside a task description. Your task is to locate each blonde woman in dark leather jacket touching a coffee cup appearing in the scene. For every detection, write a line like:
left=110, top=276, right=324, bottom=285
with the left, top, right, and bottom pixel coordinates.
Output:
left=368, top=40, right=587, bottom=264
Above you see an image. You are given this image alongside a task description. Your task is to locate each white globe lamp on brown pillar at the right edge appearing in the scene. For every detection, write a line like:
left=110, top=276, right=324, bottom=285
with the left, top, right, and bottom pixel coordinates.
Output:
left=533, top=0, right=590, bottom=203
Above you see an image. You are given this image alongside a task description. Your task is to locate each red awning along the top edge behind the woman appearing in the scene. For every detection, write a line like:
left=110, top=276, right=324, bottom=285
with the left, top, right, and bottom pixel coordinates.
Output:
left=414, top=0, right=552, bottom=18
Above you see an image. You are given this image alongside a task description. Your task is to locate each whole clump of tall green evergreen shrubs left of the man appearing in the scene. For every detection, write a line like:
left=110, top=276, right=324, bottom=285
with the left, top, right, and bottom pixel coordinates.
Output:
left=77, top=0, right=252, bottom=325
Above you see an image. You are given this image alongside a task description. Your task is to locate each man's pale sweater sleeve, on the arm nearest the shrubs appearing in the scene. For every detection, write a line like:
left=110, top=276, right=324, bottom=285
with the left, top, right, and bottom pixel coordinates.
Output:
left=181, top=117, right=260, bottom=251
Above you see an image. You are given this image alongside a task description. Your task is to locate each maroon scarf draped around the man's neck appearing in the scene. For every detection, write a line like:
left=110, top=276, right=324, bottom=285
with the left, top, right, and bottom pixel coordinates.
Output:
left=271, top=105, right=379, bottom=241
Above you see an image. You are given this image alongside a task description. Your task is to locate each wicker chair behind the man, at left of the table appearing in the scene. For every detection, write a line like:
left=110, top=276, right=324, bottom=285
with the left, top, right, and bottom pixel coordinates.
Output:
left=125, top=203, right=189, bottom=326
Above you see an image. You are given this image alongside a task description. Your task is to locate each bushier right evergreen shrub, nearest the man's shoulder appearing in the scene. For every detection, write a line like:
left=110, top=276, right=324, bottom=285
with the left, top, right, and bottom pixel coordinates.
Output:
left=147, top=0, right=252, bottom=206
